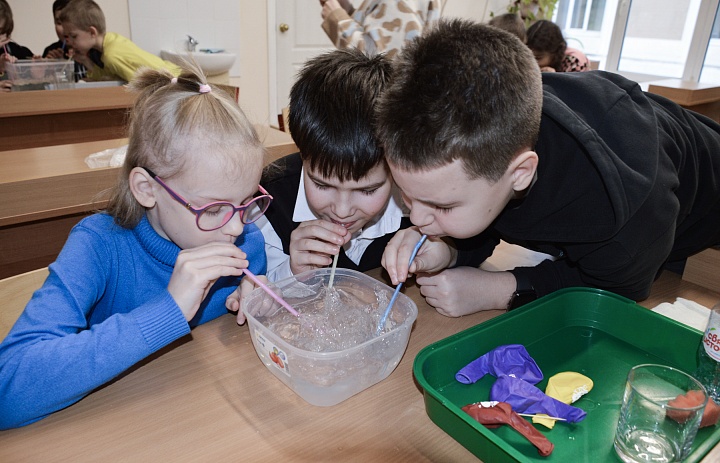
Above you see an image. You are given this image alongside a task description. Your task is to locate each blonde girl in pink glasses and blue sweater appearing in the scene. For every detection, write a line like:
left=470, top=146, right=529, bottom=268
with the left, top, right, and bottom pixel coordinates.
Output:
left=0, top=63, right=269, bottom=429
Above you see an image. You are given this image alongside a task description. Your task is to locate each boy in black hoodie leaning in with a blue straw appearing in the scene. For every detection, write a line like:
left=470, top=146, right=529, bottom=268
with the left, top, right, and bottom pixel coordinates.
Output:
left=378, top=21, right=720, bottom=316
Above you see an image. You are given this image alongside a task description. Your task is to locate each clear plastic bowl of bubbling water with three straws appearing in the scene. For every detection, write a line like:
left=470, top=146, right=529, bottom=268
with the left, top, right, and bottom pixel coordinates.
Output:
left=242, top=269, right=417, bottom=406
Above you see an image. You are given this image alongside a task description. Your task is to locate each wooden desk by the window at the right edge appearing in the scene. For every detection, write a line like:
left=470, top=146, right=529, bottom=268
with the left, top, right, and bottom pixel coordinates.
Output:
left=648, top=79, right=720, bottom=122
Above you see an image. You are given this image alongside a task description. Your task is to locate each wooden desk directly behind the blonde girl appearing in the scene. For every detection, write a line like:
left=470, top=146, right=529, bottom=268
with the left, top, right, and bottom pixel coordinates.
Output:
left=0, top=127, right=297, bottom=278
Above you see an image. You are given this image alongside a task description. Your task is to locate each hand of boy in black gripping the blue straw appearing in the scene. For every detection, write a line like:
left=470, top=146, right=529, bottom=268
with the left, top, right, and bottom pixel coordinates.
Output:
left=381, top=227, right=457, bottom=285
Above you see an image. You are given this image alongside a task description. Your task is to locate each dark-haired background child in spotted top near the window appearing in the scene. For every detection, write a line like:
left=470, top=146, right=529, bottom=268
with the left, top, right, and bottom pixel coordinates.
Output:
left=527, top=19, right=590, bottom=72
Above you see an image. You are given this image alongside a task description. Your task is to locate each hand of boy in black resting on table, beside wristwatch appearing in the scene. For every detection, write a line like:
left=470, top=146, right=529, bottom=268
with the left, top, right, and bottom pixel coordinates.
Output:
left=415, top=267, right=516, bottom=317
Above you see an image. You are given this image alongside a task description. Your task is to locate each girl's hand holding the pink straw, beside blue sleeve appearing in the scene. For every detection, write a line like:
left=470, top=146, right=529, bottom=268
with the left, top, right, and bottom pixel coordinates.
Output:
left=168, top=243, right=248, bottom=321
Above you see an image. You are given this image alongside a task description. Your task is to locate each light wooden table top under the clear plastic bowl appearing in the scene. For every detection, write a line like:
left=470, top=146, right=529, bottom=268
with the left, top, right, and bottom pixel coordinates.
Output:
left=0, top=262, right=720, bottom=462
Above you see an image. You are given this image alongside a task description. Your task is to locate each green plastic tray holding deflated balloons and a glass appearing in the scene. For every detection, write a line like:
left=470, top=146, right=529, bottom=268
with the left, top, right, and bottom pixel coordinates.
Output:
left=413, top=288, right=720, bottom=463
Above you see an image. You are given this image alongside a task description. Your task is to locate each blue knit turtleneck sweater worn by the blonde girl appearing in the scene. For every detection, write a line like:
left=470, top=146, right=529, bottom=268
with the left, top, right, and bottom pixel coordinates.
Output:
left=0, top=214, right=266, bottom=429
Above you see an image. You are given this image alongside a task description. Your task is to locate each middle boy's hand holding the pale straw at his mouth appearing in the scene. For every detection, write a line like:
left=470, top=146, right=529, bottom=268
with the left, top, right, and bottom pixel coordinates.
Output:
left=290, top=219, right=350, bottom=275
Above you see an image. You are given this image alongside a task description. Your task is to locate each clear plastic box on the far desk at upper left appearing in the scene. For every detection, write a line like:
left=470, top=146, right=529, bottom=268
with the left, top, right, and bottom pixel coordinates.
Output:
left=5, top=59, right=75, bottom=92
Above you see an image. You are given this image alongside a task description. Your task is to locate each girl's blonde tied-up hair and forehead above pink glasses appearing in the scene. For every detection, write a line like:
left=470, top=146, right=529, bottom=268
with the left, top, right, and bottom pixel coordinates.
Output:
left=107, top=64, right=265, bottom=228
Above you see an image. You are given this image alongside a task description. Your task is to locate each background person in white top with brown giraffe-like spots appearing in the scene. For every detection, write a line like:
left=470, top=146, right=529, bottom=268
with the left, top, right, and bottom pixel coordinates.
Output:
left=320, top=0, right=444, bottom=58
